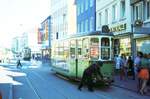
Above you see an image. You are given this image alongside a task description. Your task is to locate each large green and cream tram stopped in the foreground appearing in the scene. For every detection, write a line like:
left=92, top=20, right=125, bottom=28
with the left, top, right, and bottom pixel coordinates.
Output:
left=51, top=31, right=114, bottom=84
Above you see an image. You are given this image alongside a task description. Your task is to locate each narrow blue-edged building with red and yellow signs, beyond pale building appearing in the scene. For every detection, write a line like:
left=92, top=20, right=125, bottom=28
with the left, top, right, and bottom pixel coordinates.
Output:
left=38, top=16, right=51, bottom=59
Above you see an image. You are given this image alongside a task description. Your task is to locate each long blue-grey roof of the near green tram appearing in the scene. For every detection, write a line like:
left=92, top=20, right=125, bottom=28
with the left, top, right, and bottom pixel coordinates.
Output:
left=70, top=31, right=113, bottom=37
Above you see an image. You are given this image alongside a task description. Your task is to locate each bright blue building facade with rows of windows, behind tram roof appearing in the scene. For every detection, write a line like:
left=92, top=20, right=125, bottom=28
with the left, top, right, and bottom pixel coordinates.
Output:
left=75, top=0, right=96, bottom=33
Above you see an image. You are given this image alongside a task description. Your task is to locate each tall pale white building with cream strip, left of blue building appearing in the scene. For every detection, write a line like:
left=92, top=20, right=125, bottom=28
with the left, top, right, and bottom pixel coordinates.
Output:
left=51, top=0, right=76, bottom=41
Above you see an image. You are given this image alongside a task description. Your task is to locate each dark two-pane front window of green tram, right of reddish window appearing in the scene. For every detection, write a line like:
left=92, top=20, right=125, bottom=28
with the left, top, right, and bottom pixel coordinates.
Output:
left=101, top=38, right=110, bottom=60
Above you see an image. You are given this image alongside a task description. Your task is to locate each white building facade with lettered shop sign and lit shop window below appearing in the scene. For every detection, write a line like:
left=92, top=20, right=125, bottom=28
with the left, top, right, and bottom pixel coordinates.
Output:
left=96, top=0, right=132, bottom=55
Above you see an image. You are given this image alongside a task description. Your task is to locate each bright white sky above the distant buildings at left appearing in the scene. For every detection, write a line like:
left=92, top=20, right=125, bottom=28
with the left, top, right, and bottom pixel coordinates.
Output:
left=0, top=0, right=50, bottom=47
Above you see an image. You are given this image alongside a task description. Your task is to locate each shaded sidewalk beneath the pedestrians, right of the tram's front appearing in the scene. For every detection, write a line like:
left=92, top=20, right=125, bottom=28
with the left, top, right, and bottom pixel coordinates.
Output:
left=113, top=75, right=150, bottom=96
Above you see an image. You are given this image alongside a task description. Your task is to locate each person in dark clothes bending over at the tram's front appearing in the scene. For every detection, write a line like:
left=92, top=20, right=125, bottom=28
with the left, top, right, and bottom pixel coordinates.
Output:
left=78, top=62, right=103, bottom=91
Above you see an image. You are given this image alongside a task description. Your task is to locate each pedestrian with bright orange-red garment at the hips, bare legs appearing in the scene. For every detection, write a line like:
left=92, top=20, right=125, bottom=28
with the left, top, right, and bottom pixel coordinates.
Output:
left=138, top=54, right=149, bottom=95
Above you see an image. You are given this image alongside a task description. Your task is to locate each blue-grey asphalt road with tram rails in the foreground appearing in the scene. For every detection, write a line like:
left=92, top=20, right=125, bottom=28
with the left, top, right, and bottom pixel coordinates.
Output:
left=1, top=62, right=149, bottom=99
